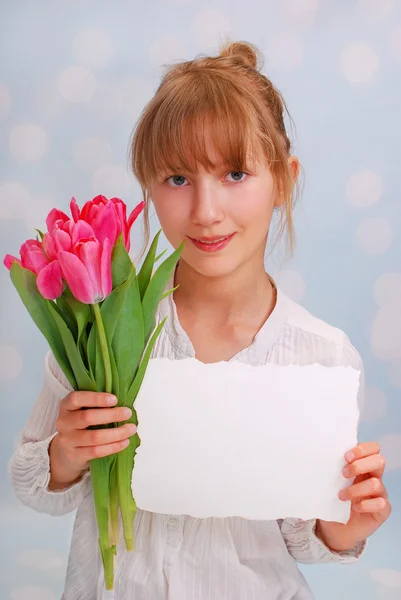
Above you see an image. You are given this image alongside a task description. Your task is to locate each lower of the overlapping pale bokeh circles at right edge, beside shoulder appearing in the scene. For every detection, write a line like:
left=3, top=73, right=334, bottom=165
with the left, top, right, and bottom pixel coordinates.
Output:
left=370, top=305, right=401, bottom=360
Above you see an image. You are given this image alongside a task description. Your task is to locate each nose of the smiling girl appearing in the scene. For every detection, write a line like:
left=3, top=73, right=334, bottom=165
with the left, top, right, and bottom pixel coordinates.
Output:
left=191, top=178, right=224, bottom=227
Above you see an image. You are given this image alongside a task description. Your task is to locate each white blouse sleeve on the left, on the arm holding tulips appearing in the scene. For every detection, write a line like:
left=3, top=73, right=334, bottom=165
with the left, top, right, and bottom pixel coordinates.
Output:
left=8, top=352, right=90, bottom=515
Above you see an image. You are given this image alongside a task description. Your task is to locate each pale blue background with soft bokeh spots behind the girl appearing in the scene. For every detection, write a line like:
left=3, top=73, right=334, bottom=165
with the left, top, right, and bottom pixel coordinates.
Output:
left=0, top=0, right=401, bottom=600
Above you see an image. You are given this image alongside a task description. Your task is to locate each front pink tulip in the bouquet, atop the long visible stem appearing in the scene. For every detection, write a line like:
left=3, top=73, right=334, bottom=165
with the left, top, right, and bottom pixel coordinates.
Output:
left=57, top=236, right=112, bottom=304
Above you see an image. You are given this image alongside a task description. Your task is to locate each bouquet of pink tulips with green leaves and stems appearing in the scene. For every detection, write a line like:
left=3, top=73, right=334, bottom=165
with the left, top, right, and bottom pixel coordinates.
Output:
left=4, top=196, right=182, bottom=589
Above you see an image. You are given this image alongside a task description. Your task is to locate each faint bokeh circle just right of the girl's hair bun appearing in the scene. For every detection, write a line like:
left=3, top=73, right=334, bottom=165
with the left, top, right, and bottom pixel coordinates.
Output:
left=266, top=31, right=303, bottom=71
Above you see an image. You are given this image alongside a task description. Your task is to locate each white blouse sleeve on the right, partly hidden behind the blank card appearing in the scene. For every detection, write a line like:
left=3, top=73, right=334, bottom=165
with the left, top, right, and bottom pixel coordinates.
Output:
left=278, top=335, right=367, bottom=564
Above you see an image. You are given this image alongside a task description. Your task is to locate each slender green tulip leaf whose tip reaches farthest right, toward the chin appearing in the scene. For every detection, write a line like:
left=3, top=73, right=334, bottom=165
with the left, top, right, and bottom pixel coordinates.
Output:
left=142, top=242, right=184, bottom=343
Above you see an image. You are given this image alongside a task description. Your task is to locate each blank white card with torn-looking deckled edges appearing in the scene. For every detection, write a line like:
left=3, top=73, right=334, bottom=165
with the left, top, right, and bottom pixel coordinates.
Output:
left=132, top=358, right=360, bottom=523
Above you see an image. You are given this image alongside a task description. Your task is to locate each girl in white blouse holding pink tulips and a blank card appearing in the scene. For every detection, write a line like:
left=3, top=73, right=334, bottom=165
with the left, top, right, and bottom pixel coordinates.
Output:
left=11, top=43, right=390, bottom=600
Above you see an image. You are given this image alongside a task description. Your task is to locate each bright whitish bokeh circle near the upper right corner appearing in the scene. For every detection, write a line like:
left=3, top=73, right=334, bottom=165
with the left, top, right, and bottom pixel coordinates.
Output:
left=340, top=42, right=379, bottom=84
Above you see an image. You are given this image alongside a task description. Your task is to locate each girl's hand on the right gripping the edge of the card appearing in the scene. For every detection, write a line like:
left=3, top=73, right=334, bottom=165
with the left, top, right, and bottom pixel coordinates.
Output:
left=316, top=442, right=391, bottom=552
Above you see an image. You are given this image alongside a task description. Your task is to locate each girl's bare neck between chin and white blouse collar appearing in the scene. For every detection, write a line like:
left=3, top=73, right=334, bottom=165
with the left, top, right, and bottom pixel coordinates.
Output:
left=174, top=261, right=274, bottom=322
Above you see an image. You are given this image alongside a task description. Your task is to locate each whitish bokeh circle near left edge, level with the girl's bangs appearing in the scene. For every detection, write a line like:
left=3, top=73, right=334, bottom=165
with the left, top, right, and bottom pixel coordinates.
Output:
left=9, top=123, right=49, bottom=162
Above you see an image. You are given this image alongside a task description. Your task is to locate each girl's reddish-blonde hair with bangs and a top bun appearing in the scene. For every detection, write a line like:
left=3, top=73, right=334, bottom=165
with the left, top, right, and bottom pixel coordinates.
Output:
left=130, top=42, right=297, bottom=253
